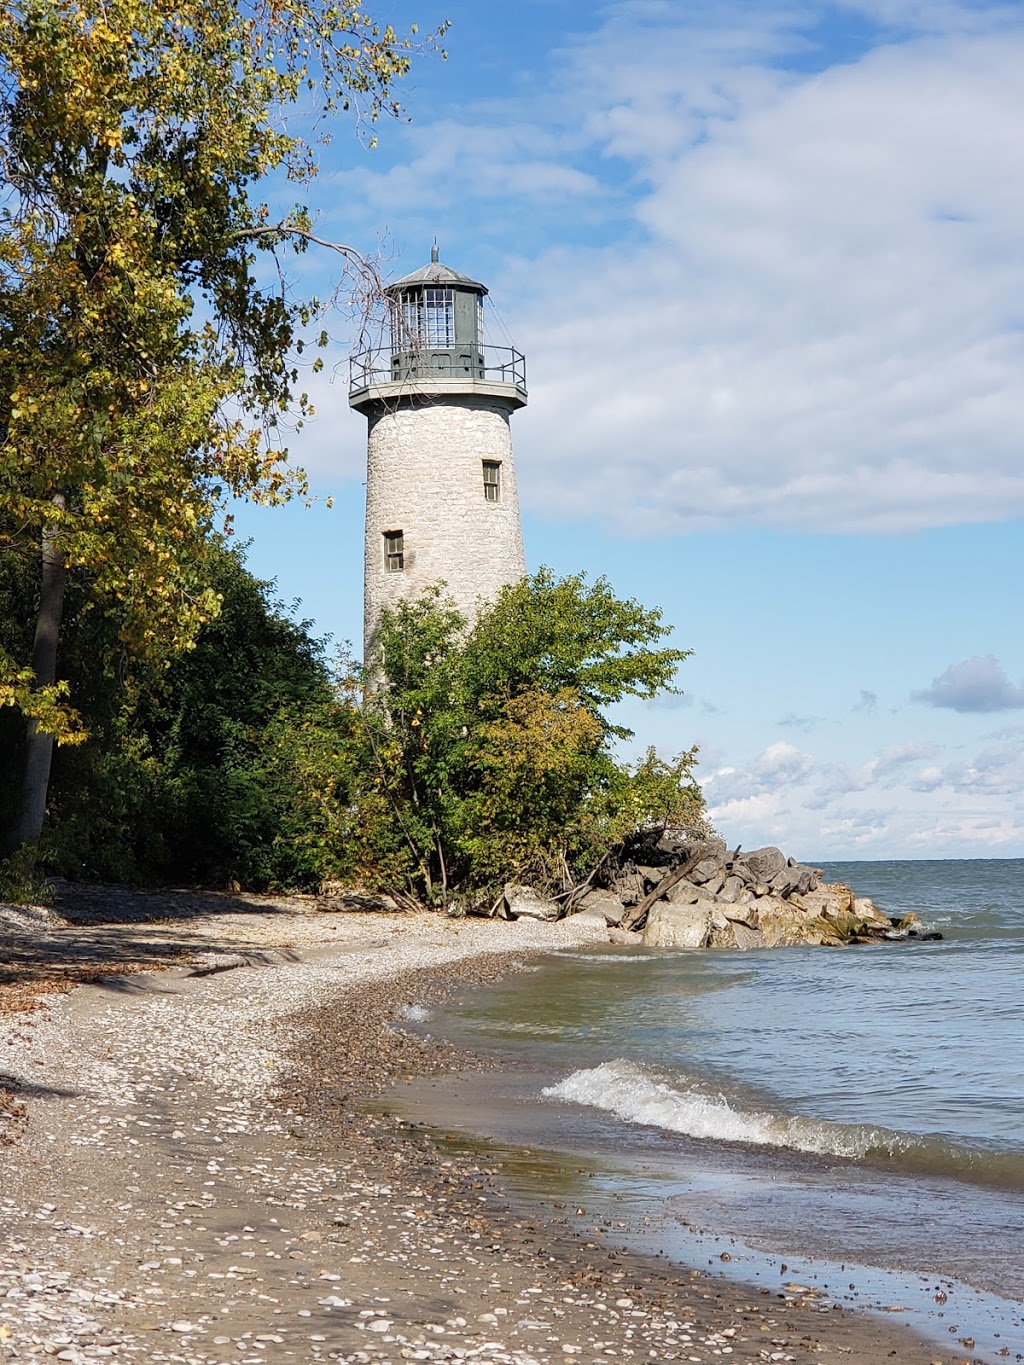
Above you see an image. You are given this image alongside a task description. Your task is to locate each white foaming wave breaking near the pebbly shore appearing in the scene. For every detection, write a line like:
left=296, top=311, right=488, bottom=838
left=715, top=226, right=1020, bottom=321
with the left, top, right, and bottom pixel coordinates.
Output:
left=542, top=1059, right=1024, bottom=1189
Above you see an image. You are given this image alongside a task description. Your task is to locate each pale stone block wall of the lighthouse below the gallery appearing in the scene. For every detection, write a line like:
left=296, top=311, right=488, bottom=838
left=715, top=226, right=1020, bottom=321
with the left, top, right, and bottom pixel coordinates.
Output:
left=363, top=394, right=526, bottom=658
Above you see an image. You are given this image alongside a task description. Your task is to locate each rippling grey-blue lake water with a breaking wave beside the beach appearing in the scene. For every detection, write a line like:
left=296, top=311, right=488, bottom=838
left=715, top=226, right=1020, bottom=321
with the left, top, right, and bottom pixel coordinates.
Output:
left=393, top=859, right=1024, bottom=1360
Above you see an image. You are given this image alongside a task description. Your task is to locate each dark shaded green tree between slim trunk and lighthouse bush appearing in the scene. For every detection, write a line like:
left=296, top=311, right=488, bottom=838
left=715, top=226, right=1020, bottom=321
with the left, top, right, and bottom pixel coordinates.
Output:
left=41, top=541, right=332, bottom=886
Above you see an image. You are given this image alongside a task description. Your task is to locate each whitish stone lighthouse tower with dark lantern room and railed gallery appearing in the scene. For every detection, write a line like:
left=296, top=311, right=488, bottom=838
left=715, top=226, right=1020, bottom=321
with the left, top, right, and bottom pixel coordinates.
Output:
left=348, top=247, right=526, bottom=659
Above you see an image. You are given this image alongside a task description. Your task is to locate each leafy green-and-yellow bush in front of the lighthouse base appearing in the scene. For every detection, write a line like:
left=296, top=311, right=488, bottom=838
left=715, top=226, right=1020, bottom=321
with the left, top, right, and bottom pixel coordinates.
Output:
left=347, top=571, right=703, bottom=904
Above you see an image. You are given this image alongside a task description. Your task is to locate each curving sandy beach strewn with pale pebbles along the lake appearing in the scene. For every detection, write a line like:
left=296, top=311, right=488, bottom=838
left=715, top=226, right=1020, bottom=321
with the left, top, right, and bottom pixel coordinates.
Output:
left=0, top=893, right=971, bottom=1365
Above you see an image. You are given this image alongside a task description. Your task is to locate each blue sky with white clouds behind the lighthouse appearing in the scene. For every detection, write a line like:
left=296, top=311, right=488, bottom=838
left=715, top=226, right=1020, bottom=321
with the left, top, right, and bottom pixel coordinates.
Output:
left=236, top=0, right=1024, bottom=860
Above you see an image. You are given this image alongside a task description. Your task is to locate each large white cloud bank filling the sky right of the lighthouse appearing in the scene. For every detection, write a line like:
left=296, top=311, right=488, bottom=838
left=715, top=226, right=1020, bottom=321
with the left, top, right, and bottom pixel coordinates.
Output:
left=516, top=22, right=1024, bottom=535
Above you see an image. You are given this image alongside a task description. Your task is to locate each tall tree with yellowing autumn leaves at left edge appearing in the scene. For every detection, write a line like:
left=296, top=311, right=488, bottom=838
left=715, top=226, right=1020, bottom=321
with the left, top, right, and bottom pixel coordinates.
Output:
left=0, top=0, right=442, bottom=848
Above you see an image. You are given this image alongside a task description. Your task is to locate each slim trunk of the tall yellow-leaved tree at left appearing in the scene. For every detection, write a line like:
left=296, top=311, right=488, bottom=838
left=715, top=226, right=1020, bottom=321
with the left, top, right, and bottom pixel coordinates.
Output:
left=4, top=493, right=67, bottom=854
